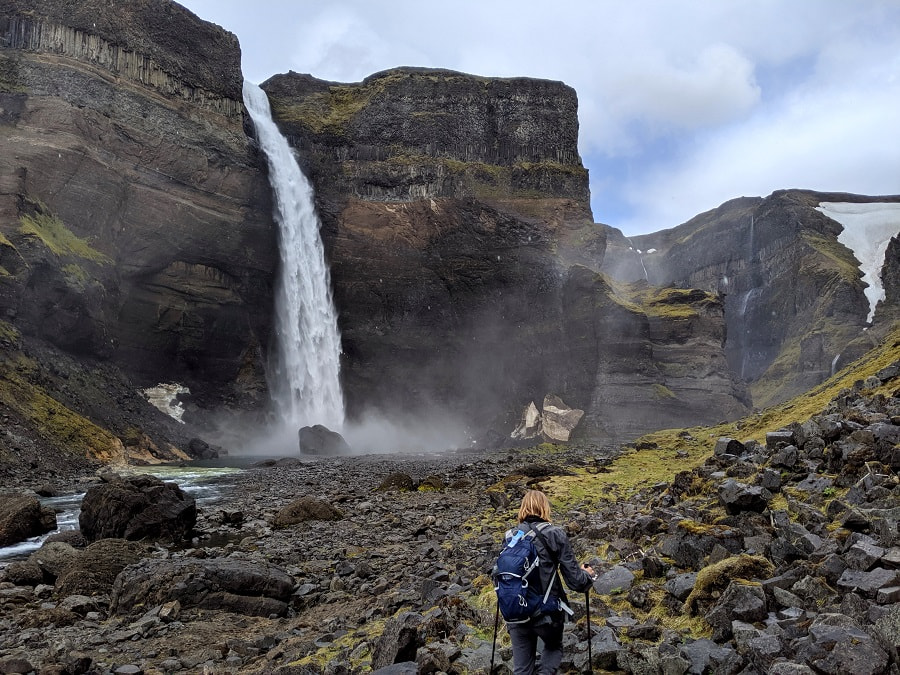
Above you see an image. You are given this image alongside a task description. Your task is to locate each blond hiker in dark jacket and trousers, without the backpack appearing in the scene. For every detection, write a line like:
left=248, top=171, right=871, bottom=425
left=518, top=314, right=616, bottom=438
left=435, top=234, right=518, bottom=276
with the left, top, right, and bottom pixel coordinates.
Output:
left=506, top=490, right=597, bottom=675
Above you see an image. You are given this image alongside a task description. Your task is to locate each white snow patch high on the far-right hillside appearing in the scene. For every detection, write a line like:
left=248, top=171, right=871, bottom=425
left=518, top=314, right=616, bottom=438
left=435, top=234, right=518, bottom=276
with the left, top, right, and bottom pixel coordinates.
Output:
left=816, top=202, right=900, bottom=323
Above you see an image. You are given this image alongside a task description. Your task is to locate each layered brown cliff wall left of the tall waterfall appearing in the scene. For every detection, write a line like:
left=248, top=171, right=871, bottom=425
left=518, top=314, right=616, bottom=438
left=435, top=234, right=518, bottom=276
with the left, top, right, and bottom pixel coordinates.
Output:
left=0, top=0, right=277, bottom=401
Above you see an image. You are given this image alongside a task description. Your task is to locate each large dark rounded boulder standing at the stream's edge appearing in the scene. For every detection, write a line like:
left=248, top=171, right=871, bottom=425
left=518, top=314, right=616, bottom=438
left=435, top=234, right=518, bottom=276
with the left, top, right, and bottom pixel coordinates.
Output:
left=78, top=476, right=197, bottom=541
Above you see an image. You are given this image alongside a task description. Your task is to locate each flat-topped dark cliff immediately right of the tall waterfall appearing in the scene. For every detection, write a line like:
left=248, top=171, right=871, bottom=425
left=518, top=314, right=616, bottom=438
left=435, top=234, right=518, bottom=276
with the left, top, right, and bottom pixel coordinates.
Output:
left=263, top=68, right=743, bottom=438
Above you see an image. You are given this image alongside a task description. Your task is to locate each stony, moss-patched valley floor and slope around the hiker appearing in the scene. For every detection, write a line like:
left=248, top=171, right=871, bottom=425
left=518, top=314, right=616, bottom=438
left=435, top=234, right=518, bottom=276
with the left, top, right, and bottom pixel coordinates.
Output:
left=0, top=364, right=900, bottom=675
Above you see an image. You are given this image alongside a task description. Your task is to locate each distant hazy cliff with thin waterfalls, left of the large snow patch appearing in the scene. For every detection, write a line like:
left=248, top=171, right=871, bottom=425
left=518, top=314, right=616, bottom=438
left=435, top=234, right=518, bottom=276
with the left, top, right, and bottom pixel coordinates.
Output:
left=604, top=190, right=897, bottom=407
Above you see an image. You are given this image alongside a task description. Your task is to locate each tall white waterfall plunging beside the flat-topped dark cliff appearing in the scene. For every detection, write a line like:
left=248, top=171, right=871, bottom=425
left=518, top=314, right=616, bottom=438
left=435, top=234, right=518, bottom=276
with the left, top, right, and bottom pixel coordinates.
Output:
left=244, top=82, right=344, bottom=430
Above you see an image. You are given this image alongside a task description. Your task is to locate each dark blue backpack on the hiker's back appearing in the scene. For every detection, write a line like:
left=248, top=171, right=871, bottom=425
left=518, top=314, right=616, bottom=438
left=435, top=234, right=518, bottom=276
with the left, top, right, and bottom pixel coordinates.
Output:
left=494, top=529, right=559, bottom=623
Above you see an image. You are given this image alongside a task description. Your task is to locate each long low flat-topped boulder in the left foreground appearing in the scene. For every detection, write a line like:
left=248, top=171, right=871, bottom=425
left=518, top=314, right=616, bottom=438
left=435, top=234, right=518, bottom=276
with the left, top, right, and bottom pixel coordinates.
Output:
left=111, top=558, right=294, bottom=616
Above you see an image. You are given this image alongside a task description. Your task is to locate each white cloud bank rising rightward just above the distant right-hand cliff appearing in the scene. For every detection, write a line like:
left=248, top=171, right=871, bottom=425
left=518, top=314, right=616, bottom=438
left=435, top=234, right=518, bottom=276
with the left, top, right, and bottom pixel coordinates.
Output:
left=620, top=69, right=900, bottom=232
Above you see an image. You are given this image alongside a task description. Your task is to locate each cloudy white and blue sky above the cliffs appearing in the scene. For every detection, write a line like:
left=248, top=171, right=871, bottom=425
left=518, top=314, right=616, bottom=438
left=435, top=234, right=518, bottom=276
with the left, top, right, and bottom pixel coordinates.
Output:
left=180, top=0, right=900, bottom=235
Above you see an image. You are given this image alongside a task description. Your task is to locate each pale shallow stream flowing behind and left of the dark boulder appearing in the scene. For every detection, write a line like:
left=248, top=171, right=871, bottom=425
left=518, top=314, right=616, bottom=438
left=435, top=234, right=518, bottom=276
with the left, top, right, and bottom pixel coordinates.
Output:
left=0, top=458, right=243, bottom=568
